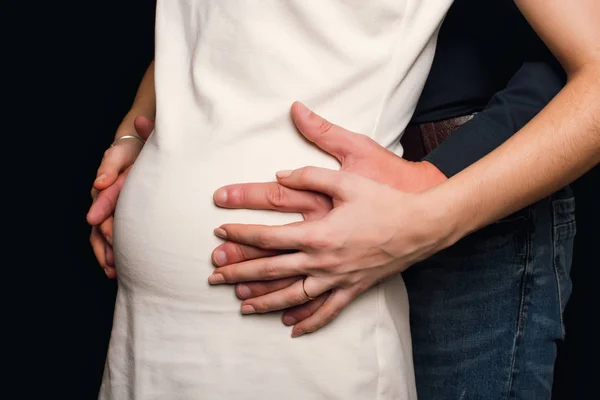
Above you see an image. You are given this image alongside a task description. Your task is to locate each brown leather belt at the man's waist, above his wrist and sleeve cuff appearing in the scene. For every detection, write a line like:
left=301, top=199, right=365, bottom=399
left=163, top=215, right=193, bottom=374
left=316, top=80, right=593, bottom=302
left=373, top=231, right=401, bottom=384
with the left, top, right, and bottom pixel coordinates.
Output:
left=400, top=114, right=475, bottom=161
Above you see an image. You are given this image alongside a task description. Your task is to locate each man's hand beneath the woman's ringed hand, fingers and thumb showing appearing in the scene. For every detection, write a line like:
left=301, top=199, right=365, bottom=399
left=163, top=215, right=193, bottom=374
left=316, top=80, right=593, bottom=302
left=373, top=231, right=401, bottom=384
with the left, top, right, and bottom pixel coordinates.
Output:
left=213, top=103, right=447, bottom=332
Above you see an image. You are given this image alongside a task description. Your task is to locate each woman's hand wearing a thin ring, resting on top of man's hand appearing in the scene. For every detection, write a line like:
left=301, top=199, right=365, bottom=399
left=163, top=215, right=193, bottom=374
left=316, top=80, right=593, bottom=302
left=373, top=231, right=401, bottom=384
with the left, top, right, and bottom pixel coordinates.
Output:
left=209, top=167, right=454, bottom=337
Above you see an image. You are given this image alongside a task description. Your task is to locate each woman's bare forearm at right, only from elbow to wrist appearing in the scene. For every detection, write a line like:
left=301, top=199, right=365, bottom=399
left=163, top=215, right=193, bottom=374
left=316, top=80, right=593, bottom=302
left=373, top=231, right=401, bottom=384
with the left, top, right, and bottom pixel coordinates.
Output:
left=433, top=64, right=600, bottom=239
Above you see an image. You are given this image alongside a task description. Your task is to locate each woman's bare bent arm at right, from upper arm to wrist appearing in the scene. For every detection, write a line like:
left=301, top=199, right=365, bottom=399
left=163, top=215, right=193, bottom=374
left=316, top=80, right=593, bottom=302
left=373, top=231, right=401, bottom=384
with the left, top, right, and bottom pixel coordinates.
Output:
left=432, top=0, right=600, bottom=244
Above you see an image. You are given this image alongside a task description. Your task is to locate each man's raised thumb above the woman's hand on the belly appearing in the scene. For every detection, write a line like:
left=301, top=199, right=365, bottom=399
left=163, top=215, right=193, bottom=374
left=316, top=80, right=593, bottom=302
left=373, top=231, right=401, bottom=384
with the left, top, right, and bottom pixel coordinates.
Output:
left=291, top=101, right=366, bottom=163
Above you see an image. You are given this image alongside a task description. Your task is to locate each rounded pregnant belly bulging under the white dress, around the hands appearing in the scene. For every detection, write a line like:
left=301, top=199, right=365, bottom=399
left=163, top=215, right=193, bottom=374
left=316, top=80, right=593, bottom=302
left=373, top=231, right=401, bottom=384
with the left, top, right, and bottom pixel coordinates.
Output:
left=114, top=130, right=339, bottom=304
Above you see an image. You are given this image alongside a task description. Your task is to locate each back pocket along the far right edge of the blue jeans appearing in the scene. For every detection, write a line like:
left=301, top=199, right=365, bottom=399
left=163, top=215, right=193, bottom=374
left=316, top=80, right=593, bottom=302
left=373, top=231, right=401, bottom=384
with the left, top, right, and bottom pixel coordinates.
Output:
left=552, top=197, right=577, bottom=335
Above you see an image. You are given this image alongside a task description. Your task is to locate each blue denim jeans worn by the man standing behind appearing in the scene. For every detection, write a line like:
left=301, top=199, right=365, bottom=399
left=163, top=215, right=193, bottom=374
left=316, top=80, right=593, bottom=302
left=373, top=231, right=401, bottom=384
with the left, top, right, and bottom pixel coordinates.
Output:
left=404, top=187, right=575, bottom=400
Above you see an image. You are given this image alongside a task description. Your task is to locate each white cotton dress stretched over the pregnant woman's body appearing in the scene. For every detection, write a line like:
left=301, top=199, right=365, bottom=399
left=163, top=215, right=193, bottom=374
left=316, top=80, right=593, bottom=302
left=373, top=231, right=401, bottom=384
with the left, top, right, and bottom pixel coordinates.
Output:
left=100, top=0, right=451, bottom=400
